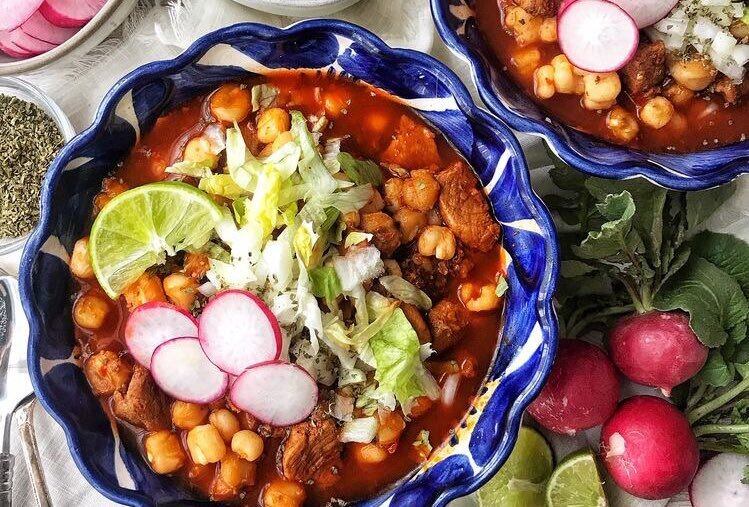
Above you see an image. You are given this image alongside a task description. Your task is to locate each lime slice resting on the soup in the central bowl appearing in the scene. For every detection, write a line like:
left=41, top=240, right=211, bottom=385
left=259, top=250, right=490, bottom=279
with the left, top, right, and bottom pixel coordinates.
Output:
left=89, top=181, right=222, bottom=298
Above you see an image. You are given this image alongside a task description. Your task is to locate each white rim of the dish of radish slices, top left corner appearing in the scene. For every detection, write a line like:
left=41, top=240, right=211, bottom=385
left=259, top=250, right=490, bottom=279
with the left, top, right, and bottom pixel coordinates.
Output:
left=0, top=0, right=138, bottom=76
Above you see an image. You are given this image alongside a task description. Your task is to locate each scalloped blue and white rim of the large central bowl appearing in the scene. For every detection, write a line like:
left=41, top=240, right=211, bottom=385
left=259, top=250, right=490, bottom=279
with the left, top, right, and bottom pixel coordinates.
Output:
left=20, top=20, right=558, bottom=506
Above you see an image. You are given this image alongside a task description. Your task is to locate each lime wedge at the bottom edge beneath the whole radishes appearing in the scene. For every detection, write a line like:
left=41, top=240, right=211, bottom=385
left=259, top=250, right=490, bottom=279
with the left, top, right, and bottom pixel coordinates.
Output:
left=546, top=450, right=608, bottom=507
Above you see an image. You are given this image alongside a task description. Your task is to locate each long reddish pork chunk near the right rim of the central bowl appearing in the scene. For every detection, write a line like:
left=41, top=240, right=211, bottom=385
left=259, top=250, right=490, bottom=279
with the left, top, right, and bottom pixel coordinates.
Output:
left=437, top=162, right=499, bottom=252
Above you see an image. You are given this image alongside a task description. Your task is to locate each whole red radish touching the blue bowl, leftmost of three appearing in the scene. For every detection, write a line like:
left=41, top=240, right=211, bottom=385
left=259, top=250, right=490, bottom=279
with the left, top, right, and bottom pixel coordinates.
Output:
left=528, top=340, right=619, bottom=435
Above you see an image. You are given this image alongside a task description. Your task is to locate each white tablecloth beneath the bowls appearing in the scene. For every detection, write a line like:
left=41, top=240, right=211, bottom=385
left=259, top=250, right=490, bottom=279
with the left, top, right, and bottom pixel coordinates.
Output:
left=7, top=0, right=749, bottom=507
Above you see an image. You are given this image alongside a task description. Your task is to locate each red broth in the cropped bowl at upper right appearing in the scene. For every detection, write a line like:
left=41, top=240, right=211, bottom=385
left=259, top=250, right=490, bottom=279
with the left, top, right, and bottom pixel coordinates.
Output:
left=475, top=0, right=749, bottom=153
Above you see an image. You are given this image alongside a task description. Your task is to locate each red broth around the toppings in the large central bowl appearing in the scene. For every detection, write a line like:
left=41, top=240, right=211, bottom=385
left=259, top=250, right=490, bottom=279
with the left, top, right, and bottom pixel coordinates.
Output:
left=76, top=72, right=501, bottom=506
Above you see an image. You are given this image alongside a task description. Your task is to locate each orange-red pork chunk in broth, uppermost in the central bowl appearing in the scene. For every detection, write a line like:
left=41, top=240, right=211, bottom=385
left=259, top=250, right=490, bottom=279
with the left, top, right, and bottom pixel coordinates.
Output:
left=381, top=115, right=440, bottom=170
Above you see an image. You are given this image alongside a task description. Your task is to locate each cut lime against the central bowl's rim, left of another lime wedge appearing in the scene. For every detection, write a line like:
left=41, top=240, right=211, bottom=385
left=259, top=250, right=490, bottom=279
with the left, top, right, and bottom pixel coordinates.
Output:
left=476, top=428, right=554, bottom=507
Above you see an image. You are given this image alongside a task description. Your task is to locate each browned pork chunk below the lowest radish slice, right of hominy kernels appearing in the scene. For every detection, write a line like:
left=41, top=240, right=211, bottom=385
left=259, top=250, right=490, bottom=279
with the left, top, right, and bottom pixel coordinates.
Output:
left=281, top=408, right=343, bottom=483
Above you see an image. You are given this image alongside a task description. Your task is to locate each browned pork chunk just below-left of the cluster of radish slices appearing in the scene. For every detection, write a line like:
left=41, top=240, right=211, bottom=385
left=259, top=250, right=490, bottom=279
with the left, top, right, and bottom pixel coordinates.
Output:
left=112, top=364, right=169, bottom=431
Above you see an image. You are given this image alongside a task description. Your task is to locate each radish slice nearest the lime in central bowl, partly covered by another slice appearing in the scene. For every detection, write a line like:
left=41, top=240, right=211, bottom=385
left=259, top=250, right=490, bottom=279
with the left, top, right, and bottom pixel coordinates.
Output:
left=125, top=301, right=198, bottom=368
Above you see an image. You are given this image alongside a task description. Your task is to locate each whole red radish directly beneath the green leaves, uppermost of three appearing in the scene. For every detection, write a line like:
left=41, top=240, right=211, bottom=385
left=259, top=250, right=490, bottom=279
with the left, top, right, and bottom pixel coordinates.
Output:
left=609, top=311, right=708, bottom=396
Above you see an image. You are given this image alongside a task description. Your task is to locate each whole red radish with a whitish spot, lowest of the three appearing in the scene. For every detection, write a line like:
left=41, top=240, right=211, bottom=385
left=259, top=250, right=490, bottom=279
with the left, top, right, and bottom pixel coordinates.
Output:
left=601, top=396, right=700, bottom=500
